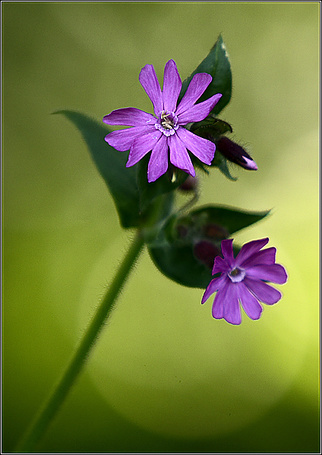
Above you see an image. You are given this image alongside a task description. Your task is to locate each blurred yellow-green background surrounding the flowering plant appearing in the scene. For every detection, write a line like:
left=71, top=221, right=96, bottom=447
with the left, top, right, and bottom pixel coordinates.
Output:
left=2, top=2, right=320, bottom=452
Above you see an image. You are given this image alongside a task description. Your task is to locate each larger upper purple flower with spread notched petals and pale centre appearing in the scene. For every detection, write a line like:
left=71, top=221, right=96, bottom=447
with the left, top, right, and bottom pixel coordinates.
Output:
left=103, top=60, right=222, bottom=182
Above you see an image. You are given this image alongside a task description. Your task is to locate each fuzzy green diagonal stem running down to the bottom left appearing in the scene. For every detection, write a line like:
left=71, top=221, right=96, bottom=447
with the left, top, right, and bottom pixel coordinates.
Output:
left=15, top=232, right=144, bottom=452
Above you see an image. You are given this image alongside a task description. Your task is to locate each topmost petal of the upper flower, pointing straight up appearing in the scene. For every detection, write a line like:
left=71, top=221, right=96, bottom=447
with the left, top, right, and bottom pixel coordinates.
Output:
left=162, top=60, right=182, bottom=112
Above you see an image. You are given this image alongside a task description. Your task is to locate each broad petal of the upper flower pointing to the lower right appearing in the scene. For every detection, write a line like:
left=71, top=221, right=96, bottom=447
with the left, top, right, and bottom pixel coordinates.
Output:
left=176, top=127, right=216, bottom=166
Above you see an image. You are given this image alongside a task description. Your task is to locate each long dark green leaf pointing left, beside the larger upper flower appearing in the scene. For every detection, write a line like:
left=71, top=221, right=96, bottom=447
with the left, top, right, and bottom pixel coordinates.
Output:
left=54, top=110, right=140, bottom=228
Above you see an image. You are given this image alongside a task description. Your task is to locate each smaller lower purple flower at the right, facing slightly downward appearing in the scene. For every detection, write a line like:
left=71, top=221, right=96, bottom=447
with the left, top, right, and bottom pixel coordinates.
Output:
left=201, top=238, right=287, bottom=325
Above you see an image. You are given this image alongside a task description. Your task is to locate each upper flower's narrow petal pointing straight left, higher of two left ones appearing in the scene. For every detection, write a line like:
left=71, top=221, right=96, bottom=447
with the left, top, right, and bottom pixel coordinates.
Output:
left=103, top=107, right=157, bottom=126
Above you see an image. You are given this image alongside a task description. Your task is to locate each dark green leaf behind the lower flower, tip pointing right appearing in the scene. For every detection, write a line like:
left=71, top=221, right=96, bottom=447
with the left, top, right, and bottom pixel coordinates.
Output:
left=148, top=206, right=269, bottom=288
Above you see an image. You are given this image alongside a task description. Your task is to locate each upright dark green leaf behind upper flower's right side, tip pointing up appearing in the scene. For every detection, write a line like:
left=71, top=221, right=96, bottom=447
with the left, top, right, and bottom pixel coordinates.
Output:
left=179, top=35, right=232, bottom=115
